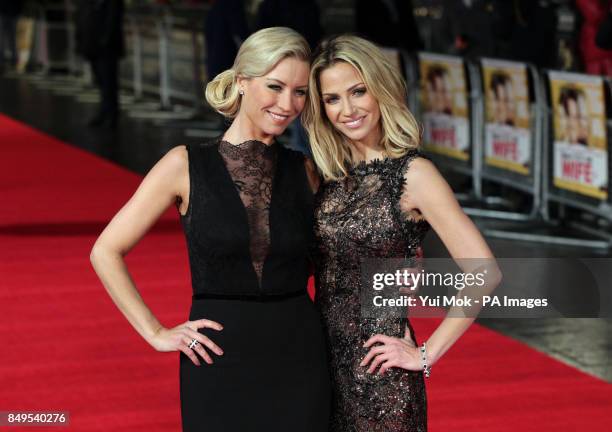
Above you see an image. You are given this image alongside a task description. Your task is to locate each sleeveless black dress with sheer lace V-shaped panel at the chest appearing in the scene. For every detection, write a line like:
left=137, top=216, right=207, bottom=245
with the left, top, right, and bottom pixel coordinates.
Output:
left=180, top=139, right=330, bottom=432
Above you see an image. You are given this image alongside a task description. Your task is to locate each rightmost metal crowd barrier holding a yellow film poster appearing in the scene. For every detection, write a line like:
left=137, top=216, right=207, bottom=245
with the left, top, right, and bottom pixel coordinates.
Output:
left=470, top=71, right=612, bottom=249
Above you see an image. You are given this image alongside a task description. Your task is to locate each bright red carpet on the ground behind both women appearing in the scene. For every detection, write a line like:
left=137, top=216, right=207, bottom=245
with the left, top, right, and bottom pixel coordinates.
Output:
left=0, top=116, right=612, bottom=432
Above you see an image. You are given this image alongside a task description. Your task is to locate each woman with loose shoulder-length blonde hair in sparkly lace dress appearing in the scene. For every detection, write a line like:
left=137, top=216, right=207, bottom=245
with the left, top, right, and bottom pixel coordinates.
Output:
left=302, top=36, right=499, bottom=432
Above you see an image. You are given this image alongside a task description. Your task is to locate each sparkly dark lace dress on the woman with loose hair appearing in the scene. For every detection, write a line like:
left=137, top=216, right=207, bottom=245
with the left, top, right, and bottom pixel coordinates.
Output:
left=315, top=150, right=430, bottom=432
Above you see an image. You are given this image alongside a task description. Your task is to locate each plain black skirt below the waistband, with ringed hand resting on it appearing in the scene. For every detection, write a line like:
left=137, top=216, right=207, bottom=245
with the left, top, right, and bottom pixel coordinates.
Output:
left=180, top=293, right=331, bottom=432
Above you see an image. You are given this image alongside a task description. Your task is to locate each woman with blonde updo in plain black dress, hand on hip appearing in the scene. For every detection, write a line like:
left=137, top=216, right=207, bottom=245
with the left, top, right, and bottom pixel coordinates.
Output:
left=91, top=27, right=330, bottom=432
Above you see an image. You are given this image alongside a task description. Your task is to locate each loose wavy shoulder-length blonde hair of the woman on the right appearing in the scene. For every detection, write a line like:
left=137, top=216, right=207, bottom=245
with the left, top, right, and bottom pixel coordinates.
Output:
left=302, top=35, right=421, bottom=180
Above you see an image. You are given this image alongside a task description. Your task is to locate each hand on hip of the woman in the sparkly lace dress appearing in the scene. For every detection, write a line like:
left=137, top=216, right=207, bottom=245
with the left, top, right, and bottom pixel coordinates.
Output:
left=360, top=334, right=423, bottom=375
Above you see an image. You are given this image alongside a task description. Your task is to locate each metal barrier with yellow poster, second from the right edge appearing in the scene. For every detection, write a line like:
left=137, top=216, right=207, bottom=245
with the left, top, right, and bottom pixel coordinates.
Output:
left=466, top=59, right=545, bottom=221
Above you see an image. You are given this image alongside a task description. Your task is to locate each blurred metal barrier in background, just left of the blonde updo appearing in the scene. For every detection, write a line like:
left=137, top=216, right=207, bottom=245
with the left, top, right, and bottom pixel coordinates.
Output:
left=121, top=6, right=208, bottom=121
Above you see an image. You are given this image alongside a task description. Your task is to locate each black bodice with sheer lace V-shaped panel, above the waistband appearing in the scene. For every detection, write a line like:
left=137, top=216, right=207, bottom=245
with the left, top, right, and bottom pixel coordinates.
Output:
left=181, top=138, right=314, bottom=299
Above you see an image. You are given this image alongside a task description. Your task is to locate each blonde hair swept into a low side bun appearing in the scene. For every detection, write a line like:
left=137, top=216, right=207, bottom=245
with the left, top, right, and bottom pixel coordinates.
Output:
left=206, top=27, right=310, bottom=118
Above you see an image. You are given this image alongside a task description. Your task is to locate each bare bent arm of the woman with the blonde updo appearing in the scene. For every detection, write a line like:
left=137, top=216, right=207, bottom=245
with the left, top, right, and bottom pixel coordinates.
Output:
left=90, top=146, right=220, bottom=360
